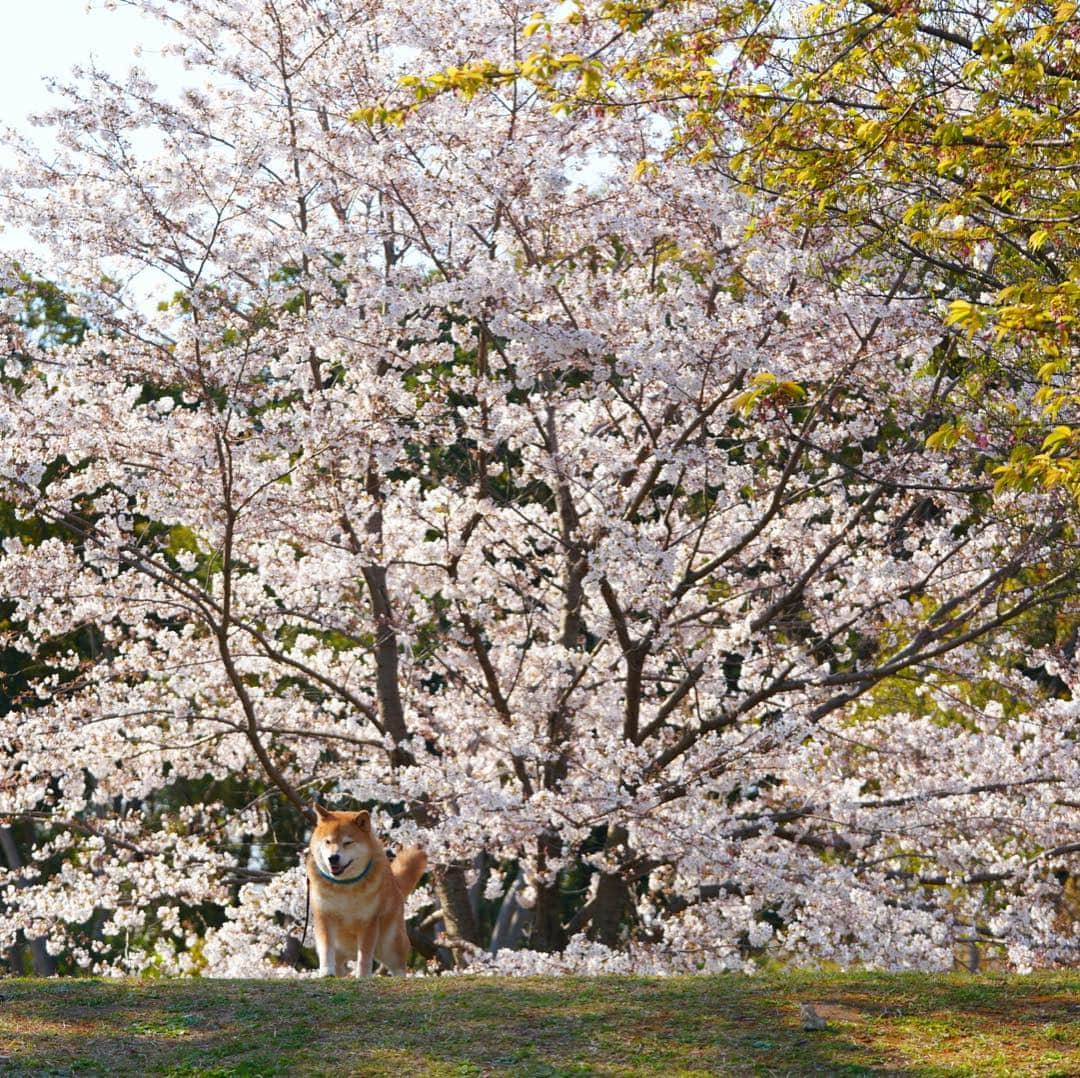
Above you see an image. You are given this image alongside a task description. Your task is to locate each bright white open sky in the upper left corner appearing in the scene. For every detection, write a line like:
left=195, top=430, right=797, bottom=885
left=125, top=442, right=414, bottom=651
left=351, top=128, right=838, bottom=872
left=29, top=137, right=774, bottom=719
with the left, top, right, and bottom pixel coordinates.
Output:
left=0, top=0, right=183, bottom=248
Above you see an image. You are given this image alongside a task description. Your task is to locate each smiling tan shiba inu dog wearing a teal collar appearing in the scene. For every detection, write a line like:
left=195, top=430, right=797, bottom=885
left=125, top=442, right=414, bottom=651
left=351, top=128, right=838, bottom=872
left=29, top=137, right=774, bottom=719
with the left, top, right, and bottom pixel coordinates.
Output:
left=308, top=805, right=428, bottom=976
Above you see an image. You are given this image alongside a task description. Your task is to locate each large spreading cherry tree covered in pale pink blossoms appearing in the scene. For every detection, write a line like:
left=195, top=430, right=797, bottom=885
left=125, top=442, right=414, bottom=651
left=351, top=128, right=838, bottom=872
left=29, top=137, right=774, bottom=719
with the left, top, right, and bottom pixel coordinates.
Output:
left=0, top=0, right=1080, bottom=974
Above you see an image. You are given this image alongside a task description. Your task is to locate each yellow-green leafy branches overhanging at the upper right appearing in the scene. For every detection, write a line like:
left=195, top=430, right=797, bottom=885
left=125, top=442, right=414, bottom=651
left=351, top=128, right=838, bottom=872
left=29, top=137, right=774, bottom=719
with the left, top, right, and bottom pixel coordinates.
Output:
left=399, top=0, right=1080, bottom=493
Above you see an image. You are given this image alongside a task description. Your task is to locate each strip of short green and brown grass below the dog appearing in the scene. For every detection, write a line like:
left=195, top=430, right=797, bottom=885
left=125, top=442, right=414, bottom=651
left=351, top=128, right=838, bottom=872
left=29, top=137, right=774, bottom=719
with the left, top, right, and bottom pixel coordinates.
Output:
left=0, top=972, right=1080, bottom=1078
